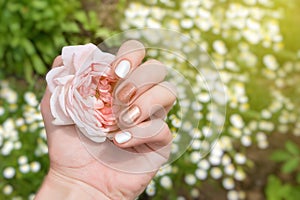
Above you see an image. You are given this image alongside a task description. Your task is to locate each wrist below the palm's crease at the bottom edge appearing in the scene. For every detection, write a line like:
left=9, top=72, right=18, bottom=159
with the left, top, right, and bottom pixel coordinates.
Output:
left=36, top=169, right=109, bottom=200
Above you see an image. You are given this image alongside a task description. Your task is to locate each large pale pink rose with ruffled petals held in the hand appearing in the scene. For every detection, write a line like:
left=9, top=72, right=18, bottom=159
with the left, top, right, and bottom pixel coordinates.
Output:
left=46, top=44, right=118, bottom=142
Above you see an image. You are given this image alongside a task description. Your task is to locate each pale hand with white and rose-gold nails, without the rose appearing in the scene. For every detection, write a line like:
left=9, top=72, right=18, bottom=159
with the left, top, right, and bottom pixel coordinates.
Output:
left=36, top=41, right=176, bottom=199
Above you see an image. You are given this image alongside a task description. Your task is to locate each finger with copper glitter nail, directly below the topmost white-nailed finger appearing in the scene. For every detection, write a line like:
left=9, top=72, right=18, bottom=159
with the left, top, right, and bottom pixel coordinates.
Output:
left=114, top=60, right=167, bottom=104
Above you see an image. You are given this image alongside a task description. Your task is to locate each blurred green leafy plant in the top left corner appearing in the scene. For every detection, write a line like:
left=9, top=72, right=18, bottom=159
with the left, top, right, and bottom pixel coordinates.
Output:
left=0, top=0, right=108, bottom=82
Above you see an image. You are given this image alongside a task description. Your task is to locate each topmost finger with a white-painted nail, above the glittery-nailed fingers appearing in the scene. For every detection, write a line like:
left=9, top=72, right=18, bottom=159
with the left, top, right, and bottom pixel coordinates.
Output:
left=112, top=40, right=146, bottom=78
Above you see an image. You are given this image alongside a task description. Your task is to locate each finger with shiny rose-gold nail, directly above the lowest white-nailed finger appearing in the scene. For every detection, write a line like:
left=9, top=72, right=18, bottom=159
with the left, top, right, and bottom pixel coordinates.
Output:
left=118, top=82, right=176, bottom=128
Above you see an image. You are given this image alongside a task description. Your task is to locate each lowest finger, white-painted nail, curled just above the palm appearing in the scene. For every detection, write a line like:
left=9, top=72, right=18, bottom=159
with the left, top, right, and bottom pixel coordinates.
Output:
left=113, top=119, right=172, bottom=150
